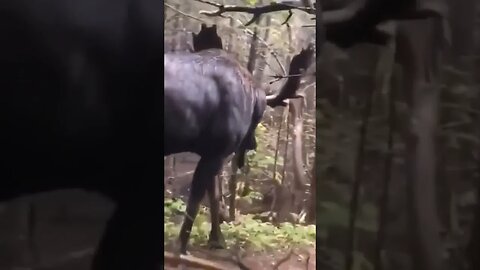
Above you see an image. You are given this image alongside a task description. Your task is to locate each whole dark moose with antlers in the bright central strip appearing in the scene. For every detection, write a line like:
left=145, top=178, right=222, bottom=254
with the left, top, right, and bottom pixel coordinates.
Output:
left=164, top=25, right=314, bottom=253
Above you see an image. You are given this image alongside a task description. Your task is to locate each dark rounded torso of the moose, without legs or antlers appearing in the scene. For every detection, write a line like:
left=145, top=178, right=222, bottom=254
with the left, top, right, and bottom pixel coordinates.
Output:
left=164, top=49, right=265, bottom=156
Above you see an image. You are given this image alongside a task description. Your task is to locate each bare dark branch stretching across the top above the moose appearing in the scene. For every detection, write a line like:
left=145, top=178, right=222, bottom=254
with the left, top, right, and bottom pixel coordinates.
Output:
left=196, top=0, right=316, bottom=26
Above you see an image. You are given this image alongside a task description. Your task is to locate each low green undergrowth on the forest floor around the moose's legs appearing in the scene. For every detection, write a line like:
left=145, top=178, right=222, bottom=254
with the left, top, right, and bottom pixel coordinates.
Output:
left=164, top=199, right=315, bottom=251
